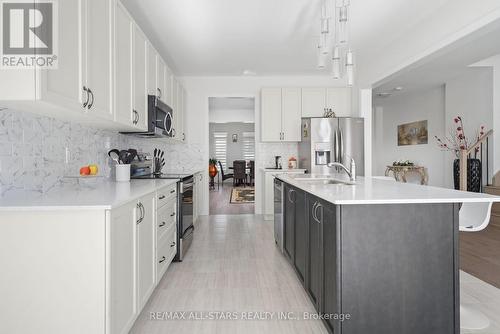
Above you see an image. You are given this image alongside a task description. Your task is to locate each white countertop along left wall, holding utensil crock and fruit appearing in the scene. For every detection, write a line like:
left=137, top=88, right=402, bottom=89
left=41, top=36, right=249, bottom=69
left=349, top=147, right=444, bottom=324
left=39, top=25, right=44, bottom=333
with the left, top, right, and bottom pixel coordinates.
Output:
left=0, top=178, right=178, bottom=211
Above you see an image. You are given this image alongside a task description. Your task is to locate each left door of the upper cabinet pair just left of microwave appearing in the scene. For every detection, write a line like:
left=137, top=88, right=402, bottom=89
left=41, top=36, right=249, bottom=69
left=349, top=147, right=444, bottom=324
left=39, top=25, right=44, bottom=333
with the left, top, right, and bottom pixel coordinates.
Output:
left=115, top=1, right=135, bottom=126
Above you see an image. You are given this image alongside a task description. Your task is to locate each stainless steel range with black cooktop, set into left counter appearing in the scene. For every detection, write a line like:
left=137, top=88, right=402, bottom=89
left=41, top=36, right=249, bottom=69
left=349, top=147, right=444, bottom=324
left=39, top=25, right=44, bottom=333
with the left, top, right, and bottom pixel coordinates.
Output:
left=131, top=174, right=194, bottom=261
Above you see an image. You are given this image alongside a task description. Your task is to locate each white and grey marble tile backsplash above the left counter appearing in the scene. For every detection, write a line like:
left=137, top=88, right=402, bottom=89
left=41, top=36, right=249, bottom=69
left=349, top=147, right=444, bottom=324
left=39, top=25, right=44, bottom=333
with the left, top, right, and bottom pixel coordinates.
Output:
left=0, top=111, right=205, bottom=194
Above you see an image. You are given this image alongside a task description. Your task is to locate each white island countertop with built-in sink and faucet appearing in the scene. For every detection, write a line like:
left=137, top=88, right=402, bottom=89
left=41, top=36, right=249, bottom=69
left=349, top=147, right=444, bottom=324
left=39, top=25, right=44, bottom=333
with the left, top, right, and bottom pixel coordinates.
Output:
left=277, top=174, right=500, bottom=205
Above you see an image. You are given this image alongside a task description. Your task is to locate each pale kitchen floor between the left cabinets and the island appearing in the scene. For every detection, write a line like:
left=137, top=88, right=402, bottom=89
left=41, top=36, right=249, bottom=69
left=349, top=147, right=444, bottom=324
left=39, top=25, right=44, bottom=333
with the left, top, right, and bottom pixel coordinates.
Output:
left=131, top=215, right=327, bottom=334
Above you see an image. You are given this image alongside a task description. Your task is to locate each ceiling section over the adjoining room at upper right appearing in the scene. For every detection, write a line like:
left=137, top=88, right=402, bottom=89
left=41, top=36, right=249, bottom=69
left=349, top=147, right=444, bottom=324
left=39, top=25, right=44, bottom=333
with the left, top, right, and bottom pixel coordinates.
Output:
left=374, top=20, right=500, bottom=98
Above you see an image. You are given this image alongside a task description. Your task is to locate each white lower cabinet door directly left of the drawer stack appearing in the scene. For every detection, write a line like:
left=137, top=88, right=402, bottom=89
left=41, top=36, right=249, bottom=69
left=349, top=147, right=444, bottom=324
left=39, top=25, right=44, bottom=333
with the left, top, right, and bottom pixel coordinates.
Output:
left=137, top=194, right=156, bottom=310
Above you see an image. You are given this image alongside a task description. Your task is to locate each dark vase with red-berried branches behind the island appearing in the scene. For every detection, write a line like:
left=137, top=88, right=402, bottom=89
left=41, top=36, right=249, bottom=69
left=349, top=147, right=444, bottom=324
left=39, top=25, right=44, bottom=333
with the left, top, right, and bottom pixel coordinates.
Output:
left=434, top=116, right=485, bottom=192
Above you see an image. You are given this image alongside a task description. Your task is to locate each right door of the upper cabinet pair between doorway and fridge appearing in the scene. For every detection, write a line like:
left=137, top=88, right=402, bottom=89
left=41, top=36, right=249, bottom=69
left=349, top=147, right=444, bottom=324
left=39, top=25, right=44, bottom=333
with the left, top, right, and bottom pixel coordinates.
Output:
left=281, top=88, right=302, bottom=142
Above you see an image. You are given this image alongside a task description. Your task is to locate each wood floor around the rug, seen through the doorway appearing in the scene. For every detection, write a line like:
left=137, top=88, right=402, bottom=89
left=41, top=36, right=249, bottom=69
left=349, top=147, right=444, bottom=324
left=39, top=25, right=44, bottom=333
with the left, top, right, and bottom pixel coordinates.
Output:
left=209, top=180, right=255, bottom=215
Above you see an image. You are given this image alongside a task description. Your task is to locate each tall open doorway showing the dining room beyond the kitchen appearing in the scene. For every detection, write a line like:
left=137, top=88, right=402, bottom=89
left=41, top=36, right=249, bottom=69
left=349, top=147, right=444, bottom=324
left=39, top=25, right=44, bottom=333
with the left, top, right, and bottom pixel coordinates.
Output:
left=208, top=97, right=255, bottom=215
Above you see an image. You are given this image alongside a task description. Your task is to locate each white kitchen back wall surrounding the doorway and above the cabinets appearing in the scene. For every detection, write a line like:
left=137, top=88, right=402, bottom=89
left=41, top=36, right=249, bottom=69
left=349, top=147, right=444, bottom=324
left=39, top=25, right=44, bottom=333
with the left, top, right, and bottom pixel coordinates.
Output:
left=180, top=76, right=352, bottom=214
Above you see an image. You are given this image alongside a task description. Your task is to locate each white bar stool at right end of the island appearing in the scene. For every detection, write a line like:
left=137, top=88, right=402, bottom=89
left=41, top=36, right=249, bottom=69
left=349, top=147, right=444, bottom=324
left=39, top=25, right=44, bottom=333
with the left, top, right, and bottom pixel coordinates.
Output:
left=458, top=202, right=493, bottom=330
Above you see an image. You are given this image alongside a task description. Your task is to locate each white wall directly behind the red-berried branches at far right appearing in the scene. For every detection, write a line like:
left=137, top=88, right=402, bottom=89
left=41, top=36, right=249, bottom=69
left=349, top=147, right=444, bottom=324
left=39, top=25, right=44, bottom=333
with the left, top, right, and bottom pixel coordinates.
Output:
left=444, top=68, right=494, bottom=188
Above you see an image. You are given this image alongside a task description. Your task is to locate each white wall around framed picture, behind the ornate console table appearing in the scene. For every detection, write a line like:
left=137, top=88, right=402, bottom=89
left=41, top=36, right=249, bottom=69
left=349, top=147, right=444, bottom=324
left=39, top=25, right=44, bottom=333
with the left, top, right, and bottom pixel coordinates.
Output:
left=373, top=86, right=445, bottom=186
